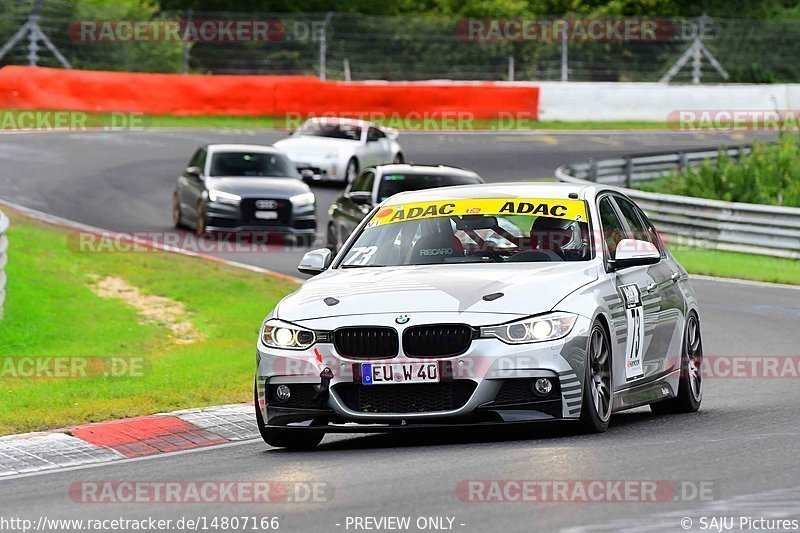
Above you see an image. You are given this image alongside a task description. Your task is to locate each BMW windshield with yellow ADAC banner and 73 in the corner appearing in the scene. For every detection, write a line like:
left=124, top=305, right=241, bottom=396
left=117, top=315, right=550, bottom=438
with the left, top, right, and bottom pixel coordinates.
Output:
left=341, top=198, right=591, bottom=268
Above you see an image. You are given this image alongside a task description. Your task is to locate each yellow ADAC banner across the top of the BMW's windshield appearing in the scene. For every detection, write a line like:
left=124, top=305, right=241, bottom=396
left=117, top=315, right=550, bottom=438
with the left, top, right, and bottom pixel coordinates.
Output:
left=367, top=198, right=587, bottom=228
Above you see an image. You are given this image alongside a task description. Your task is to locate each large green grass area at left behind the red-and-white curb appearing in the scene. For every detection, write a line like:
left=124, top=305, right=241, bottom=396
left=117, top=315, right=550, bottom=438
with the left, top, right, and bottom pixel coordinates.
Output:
left=0, top=211, right=296, bottom=434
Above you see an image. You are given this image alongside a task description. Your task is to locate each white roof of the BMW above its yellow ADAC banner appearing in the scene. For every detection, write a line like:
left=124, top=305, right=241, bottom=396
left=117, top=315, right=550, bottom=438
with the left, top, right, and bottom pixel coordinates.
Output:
left=384, top=182, right=608, bottom=205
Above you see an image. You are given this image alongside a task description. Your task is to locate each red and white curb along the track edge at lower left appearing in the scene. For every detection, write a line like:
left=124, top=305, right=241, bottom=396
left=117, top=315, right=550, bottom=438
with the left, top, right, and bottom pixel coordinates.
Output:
left=0, top=404, right=259, bottom=479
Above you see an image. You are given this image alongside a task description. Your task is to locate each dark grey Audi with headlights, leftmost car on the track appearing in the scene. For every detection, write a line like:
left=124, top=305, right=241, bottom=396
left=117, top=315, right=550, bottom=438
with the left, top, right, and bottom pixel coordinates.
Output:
left=172, top=144, right=317, bottom=240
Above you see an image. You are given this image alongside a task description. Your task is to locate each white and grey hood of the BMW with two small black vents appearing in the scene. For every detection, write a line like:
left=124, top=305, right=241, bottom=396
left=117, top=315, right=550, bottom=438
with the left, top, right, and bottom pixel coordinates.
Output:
left=276, top=262, right=598, bottom=325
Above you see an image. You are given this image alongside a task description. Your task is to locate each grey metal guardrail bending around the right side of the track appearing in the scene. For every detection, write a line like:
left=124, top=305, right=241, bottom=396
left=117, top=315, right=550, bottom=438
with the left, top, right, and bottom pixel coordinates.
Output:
left=556, top=146, right=800, bottom=259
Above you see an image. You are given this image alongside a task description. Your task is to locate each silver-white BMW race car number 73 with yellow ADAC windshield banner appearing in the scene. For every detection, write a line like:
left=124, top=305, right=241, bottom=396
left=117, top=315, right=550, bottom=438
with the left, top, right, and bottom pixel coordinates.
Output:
left=255, top=183, right=703, bottom=447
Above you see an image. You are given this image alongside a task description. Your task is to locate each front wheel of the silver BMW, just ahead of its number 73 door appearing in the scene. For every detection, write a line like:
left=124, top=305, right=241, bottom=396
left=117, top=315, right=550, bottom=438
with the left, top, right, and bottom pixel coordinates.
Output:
left=580, top=321, right=613, bottom=433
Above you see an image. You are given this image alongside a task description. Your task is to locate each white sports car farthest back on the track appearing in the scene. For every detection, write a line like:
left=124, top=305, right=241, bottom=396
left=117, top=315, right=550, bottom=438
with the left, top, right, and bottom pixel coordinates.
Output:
left=275, top=118, right=405, bottom=185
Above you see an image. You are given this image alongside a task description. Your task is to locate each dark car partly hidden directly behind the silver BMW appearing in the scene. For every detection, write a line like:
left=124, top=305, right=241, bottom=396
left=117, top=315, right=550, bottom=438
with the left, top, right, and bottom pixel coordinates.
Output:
left=327, top=164, right=483, bottom=253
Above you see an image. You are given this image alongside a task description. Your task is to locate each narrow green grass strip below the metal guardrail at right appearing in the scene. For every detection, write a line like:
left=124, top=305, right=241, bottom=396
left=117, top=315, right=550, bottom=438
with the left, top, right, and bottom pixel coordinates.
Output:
left=670, top=247, right=800, bottom=285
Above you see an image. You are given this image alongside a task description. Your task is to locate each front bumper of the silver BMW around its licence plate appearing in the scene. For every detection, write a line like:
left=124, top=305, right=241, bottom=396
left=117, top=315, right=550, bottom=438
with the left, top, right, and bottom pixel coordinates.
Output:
left=256, top=317, right=589, bottom=432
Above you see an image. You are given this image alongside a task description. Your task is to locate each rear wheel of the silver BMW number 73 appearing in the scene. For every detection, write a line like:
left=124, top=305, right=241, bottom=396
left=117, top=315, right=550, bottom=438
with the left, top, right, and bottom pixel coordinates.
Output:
left=650, top=311, right=703, bottom=415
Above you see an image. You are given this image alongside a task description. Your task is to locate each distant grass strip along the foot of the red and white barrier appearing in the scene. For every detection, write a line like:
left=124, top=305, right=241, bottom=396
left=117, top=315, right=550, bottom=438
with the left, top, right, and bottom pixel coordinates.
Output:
left=0, top=110, right=669, bottom=131
